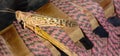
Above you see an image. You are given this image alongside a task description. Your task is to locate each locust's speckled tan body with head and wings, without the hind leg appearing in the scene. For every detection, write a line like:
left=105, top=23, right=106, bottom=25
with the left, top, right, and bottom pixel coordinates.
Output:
left=16, top=11, right=77, bottom=27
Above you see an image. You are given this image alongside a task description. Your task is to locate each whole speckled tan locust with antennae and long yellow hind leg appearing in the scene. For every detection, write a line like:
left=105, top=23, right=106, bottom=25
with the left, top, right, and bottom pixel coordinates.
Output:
left=0, top=10, right=77, bottom=56
